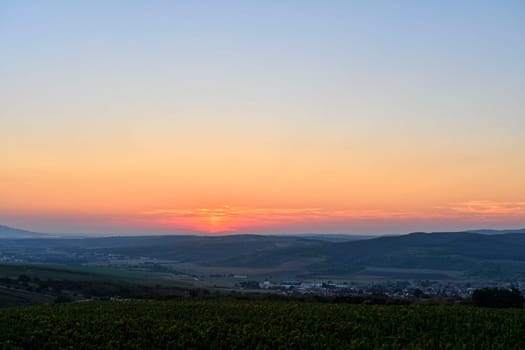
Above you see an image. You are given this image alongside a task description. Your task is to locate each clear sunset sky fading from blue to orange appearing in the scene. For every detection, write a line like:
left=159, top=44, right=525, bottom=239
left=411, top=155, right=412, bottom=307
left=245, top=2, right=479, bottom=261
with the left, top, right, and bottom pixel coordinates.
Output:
left=0, top=0, right=525, bottom=234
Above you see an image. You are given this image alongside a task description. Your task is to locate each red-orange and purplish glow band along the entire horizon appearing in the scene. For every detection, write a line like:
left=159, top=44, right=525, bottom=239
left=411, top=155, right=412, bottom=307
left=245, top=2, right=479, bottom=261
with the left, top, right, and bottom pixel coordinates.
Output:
left=4, top=200, right=525, bottom=234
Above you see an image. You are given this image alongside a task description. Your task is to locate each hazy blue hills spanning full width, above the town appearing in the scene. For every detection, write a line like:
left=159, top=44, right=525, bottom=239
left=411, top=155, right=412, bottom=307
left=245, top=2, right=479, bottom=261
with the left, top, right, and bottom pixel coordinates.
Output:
left=0, top=227, right=525, bottom=280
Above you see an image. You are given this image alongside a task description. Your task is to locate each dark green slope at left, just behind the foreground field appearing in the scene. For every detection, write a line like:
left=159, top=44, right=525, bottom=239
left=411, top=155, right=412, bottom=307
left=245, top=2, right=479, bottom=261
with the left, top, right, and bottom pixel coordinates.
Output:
left=0, top=264, right=199, bottom=307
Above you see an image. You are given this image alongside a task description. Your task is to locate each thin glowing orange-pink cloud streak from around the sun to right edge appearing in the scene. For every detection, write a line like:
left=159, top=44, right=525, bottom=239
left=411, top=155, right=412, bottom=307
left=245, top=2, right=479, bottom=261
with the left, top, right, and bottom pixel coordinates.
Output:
left=138, top=200, right=525, bottom=233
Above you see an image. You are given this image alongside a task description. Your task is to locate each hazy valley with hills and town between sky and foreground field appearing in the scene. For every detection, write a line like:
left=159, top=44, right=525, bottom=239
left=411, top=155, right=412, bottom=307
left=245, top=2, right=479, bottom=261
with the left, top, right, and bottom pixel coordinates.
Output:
left=0, top=227, right=525, bottom=307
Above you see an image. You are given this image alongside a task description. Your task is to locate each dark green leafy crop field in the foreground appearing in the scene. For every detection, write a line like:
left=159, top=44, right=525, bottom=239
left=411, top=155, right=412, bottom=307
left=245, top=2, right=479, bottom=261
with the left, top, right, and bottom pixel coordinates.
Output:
left=0, top=299, right=525, bottom=349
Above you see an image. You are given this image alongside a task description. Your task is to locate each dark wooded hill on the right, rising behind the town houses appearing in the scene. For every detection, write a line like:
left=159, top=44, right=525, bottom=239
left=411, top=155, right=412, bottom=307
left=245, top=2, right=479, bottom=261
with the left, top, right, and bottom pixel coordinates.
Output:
left=210, top=232, right=525, bottom=279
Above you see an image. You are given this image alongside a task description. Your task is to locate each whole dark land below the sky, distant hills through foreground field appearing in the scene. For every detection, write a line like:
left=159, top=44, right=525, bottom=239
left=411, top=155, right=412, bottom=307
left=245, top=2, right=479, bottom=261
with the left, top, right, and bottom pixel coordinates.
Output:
left=0, top=227, right=525, bottom=349
